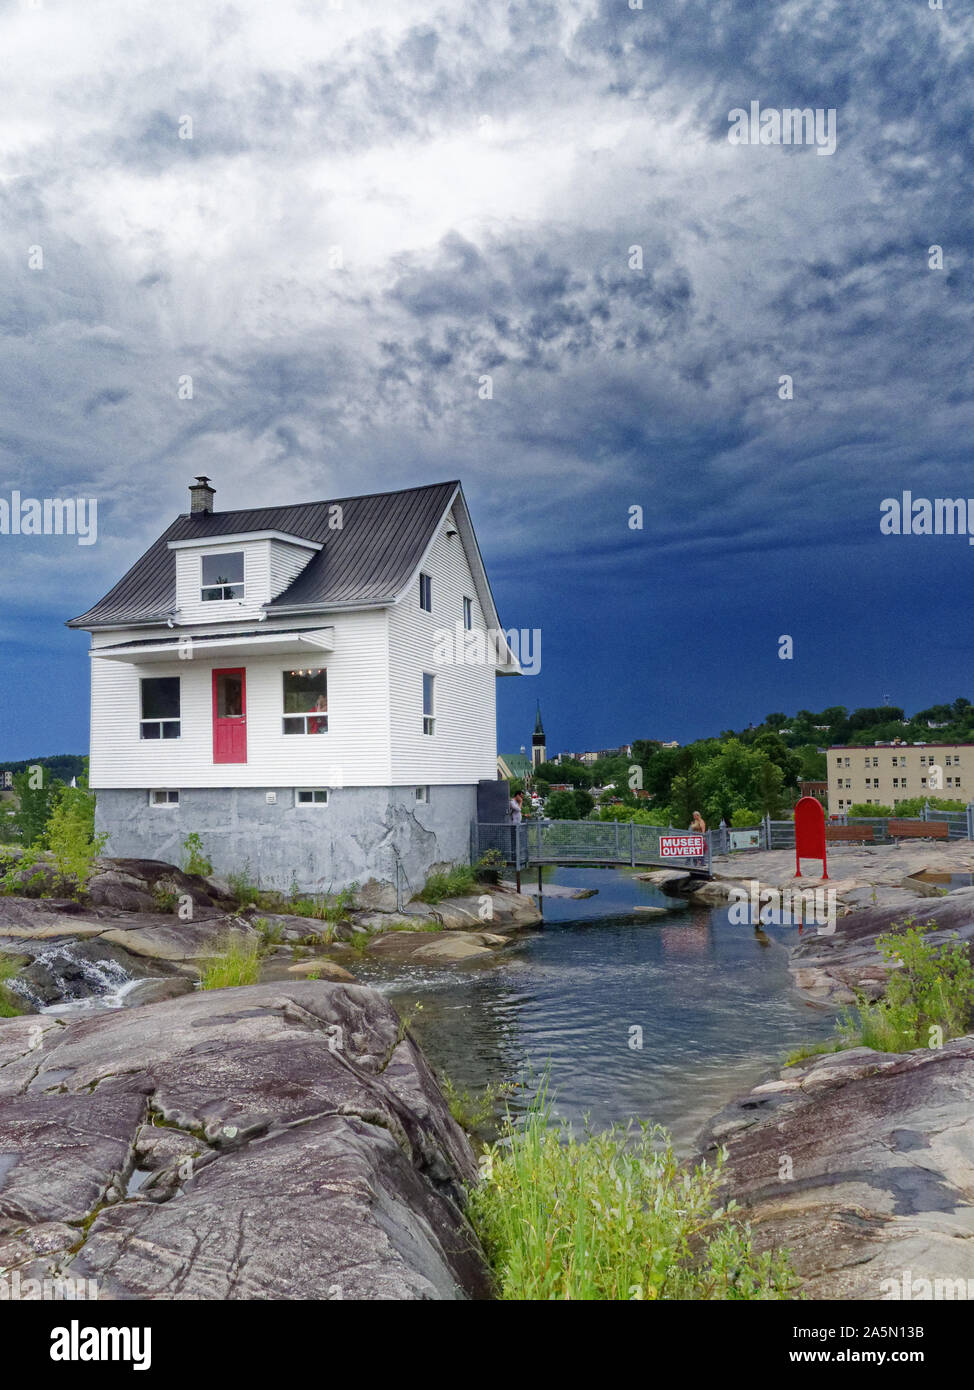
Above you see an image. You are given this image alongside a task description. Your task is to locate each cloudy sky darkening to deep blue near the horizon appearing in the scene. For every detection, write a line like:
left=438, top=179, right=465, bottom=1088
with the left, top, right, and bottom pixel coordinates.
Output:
left=0, top=0, right=974, bottom=759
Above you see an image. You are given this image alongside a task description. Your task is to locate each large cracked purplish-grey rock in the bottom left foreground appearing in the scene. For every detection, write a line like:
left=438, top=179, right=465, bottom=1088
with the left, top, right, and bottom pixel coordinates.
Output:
left=0, top=981, right=489, bottom=1300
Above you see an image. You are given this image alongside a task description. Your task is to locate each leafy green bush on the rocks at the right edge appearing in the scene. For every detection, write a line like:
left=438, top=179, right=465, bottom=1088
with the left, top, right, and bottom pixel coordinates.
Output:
left=842, top=917, right=974, bottom=1052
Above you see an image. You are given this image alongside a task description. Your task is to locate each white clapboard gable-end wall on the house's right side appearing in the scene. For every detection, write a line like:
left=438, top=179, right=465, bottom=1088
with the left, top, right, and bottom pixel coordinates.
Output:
left=389, top=516, right=497, bottom=785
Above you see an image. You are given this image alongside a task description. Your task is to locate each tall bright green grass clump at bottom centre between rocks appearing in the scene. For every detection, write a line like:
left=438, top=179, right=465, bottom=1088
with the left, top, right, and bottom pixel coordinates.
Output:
left=470, top=1093, right=800, bottom=1301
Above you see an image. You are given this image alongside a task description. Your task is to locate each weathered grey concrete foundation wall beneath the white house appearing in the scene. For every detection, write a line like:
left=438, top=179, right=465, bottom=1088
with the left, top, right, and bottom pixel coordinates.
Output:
left=94, top=787, right=477, bottom=908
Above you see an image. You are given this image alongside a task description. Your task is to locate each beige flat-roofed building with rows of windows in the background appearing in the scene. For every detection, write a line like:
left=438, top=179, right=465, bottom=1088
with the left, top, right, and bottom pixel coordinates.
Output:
left=828, top=744, right=974, bottom=815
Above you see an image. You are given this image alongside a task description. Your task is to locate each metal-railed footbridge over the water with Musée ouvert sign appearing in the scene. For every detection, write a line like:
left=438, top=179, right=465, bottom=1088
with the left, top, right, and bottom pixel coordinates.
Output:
left=472, top=820, right=711, bottom=878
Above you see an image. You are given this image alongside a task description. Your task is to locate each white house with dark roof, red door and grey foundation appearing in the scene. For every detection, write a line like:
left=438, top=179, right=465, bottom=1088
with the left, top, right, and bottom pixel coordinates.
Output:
left=68, top=477, right=518, bottom=902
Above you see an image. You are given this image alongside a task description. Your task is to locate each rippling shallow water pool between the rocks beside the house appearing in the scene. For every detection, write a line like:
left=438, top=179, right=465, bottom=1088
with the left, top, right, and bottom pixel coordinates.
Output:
left=341, top=869, right=835, bottom=1152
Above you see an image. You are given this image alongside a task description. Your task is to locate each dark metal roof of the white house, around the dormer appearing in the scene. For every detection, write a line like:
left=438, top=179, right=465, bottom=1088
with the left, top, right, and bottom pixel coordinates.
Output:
left=68, top=482, right=460, bottom=628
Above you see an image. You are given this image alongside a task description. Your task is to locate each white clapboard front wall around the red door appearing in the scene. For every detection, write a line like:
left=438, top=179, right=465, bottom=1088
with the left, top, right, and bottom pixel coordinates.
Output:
left=90, top=605, right=392, bottom=790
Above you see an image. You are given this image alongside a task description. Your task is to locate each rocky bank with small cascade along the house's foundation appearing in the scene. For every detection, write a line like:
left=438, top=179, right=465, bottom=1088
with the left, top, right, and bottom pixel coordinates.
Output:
left=0, top=859, right=540, bottom=1009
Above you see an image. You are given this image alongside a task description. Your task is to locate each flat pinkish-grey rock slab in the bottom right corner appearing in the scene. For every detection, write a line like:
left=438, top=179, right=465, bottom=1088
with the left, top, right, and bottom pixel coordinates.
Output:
left=694, top=1037, right=974, bottom=1300
